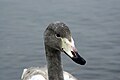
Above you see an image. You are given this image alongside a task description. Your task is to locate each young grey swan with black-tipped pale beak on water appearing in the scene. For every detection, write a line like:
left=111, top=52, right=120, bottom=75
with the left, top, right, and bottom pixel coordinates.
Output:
left=21, top=21, right=86, bottom=80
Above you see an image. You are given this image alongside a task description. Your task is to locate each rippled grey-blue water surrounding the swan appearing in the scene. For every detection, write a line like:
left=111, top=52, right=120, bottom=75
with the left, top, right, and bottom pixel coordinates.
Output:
left=0, top=0, right=120, bottom=80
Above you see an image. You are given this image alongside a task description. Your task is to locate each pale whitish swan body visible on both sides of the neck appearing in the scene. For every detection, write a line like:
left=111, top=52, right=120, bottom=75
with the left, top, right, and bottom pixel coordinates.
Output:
left=21, top=67, right=77, bottom=80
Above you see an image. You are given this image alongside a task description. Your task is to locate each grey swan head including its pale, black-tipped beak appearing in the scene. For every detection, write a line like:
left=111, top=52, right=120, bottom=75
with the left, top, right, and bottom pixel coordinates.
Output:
left=44, top=22, right=86, bottom=65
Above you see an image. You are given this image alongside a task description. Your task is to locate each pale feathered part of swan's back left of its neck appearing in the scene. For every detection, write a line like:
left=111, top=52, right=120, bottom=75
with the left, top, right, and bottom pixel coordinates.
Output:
left=21, top=67, right=48, bottom=80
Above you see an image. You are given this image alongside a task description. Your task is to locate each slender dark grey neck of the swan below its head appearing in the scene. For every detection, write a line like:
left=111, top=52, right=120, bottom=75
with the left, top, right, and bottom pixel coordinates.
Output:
left=45, top=46, right=63, bottom=80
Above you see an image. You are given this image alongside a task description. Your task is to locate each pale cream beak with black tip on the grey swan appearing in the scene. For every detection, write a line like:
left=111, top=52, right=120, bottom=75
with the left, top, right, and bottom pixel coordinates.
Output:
left=62, top=37, right=86, bottom=65
